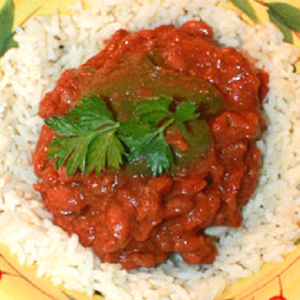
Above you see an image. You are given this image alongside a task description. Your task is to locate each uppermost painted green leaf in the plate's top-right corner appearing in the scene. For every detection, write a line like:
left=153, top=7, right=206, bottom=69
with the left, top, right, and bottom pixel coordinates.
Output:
left=266, top=2, right=300, bottom=32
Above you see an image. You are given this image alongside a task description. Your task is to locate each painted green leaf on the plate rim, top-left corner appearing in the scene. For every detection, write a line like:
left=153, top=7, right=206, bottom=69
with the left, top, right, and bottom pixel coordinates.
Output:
left=0, top=0, right=18, bottom=57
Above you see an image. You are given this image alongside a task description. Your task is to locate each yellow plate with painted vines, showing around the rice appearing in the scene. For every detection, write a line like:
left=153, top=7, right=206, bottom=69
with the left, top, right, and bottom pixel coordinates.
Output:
left=0, top=0, right=300, bottom=300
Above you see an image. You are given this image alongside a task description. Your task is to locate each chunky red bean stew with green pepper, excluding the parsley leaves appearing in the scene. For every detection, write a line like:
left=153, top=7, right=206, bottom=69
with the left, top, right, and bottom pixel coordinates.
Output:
left=34, top=21, right=268, bottom=269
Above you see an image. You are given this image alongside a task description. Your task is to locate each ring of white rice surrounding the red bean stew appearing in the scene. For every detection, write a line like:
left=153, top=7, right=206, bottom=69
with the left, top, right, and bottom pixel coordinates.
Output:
left=0, top=0, right=300, bottom=300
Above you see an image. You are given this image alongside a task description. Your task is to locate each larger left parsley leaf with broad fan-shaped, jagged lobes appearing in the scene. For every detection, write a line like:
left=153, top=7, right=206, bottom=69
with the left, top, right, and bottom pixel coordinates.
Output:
left=45, top=96, right=125, bottom=176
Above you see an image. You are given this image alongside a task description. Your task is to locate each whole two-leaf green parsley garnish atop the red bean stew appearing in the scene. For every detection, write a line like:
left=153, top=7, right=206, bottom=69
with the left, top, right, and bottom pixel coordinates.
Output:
left=45, top=96, right=199, bottom=176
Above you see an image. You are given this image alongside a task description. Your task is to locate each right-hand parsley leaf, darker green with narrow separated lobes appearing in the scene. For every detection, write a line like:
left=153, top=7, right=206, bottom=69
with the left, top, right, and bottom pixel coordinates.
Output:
left=119, top=96, right=199, bottom=176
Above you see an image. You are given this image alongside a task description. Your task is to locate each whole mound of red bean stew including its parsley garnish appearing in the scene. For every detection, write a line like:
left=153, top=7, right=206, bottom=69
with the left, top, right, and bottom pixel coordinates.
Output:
left=34, top=21, right=268, bottom=269
